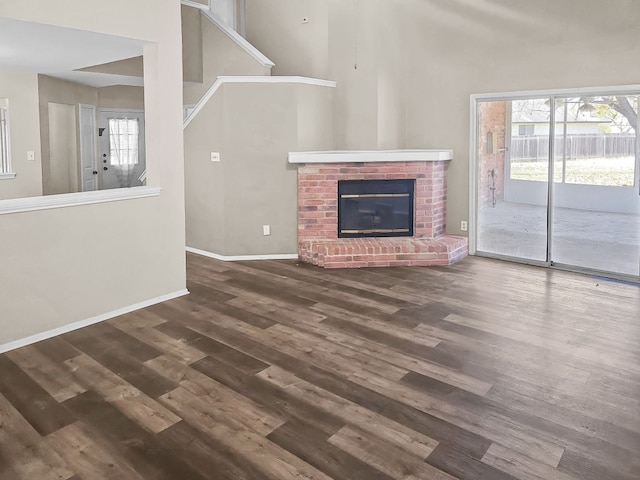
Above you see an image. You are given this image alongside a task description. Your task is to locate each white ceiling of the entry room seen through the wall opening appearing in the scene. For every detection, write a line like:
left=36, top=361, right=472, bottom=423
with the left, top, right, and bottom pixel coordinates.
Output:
left=0, top=17, right=144, bottom=87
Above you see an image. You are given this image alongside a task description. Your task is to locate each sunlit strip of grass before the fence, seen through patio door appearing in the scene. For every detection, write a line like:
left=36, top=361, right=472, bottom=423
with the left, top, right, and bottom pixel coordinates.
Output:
left=511, top=157, right=635, bottom=187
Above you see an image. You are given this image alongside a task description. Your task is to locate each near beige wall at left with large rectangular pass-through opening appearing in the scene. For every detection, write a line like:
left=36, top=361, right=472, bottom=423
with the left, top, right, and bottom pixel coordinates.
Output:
left=0, top=0, right=185, bottom=345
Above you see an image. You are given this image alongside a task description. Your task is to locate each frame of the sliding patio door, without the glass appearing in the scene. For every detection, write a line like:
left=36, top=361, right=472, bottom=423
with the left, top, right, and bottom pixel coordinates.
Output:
left=469, top=85, right=640, bottom=282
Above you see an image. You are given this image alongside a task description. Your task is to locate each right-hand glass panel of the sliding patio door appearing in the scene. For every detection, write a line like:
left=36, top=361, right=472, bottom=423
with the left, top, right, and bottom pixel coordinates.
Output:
left=551, top=95, right=640, bottom=276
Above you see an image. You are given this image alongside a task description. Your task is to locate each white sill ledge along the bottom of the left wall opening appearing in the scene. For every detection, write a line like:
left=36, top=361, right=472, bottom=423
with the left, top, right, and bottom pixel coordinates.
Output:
left=0, top=186, right=161, bottom=215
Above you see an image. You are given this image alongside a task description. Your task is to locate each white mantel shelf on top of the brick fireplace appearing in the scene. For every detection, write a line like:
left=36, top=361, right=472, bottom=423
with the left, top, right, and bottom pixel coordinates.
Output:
left=289, top=150, right=453, bottom=163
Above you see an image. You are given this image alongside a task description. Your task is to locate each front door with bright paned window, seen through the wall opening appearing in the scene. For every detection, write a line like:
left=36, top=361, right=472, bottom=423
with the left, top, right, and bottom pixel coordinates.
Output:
left=98, top=110, right=146, bottom=190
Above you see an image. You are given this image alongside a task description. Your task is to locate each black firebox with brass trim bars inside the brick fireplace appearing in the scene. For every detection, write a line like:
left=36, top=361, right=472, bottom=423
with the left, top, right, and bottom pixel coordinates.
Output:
left=338, top=180, right=415, bottom=238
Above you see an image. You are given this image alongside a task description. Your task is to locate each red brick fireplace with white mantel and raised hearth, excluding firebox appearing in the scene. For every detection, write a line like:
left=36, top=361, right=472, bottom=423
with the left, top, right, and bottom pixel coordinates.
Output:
left=289, top=150, right=468, bottom=268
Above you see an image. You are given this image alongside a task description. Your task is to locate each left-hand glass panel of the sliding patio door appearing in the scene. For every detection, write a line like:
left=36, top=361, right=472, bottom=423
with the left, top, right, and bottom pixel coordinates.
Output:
left=476, top=98, right=550, bottom=263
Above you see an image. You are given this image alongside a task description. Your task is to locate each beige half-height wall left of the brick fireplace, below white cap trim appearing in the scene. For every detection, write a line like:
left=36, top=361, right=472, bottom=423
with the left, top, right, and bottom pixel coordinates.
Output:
left=185, top=83, right=333, bottom=256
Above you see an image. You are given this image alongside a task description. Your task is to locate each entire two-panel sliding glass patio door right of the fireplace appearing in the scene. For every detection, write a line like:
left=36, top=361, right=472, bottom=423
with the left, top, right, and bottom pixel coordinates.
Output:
left=471, top=92, right=640, bottom=281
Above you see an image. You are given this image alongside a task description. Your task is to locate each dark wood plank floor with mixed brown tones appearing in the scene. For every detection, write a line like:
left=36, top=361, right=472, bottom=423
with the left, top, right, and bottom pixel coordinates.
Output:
left=0, top=255, right=640, bottom=480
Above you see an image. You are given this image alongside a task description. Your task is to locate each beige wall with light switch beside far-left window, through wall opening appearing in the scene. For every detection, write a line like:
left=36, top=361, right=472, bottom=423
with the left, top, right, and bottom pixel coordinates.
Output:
left=0, top=72, right=42, bottom=200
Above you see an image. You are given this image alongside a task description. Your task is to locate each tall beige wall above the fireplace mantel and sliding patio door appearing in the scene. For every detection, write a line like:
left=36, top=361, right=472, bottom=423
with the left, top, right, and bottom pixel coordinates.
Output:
left=247, top=0, right=640, bottom=233
